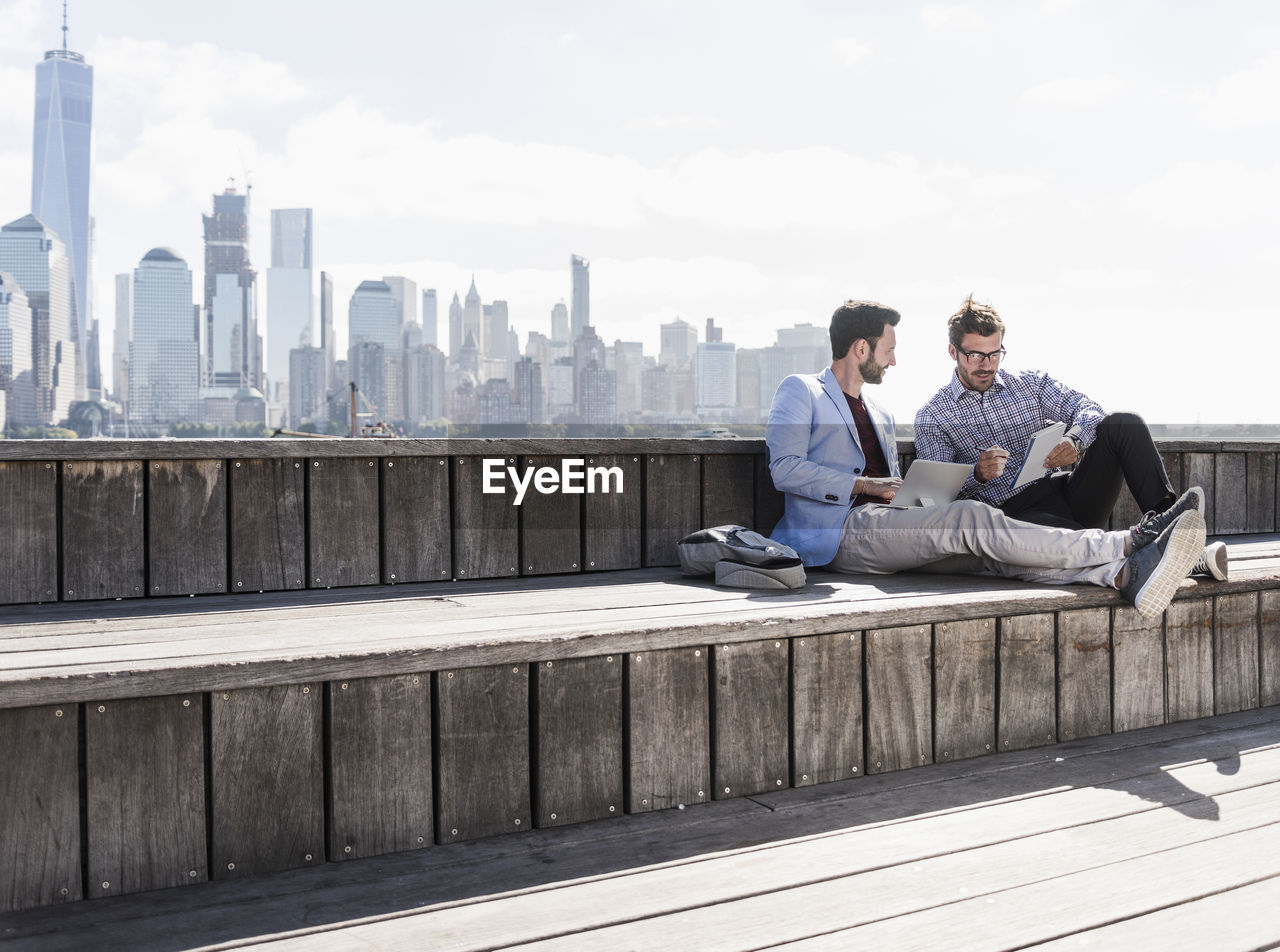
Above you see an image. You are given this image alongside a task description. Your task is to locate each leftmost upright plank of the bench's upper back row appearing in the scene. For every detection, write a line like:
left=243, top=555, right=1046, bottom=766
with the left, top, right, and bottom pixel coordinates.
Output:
left=0, top=462, right=58, bottom=604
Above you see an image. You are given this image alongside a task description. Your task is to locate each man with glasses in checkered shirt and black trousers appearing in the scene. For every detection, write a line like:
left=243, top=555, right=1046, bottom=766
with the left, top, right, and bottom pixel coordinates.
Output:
left=915, top=294, right=1226, bottom=578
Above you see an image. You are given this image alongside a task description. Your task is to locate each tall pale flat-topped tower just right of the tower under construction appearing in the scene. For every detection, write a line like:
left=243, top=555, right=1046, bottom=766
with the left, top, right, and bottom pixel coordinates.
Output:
left=266, top=209, right=317, bottom=394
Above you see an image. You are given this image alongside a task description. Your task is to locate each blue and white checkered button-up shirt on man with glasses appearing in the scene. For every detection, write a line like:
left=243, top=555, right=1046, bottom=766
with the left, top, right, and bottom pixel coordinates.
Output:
left=915, top=370, right=1106, bottom=505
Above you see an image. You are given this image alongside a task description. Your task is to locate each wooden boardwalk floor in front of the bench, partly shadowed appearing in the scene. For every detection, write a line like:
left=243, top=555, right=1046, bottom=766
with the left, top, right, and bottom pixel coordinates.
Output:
left=0, top=706, right=1280, bottom=952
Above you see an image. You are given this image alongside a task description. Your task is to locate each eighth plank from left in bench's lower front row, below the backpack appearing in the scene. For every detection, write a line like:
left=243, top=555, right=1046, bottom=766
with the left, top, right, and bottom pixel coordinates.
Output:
left=712, top=639, right=791, bottom=800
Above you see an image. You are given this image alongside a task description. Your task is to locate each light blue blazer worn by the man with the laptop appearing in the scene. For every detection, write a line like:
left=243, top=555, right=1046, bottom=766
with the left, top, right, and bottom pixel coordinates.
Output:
left=764, top=367, right=901, bottom=566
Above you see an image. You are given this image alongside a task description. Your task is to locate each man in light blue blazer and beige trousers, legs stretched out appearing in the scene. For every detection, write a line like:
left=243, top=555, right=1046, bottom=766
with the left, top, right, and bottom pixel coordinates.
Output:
left=765, top=301, right=1204, bottom=617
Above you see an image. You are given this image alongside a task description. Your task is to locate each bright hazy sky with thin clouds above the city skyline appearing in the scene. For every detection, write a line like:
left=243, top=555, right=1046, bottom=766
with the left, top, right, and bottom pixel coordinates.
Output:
left=0, top=0, right=1280, bottom=422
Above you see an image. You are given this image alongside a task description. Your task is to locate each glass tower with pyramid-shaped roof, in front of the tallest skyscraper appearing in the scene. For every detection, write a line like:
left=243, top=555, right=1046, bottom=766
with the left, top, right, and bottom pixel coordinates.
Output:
left=0, top=215, right=77, bottom=424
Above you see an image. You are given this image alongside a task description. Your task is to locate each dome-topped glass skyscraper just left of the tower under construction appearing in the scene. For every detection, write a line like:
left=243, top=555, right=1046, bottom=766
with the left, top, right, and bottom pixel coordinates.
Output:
left=129, top=248, right=200, bottom=424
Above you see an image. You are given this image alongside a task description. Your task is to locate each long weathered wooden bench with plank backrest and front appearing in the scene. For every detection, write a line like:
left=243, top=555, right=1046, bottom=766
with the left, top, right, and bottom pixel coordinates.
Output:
left=0, top=440, right=1280, bottom=908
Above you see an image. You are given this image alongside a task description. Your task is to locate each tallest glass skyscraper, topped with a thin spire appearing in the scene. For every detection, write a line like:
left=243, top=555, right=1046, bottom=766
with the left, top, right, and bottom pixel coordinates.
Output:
left=30, top=6, right=97, bottom=399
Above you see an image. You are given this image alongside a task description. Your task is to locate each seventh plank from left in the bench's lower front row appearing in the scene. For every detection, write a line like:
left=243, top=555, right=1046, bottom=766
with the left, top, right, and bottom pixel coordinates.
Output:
left=627, top=647, right=712, bottom=813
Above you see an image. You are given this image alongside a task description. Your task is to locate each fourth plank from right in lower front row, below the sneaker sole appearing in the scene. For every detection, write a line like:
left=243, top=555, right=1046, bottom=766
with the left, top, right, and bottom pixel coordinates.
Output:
left=1111, top=607, right=1165, bottom=732
